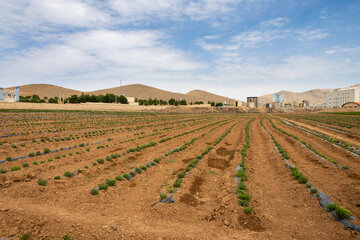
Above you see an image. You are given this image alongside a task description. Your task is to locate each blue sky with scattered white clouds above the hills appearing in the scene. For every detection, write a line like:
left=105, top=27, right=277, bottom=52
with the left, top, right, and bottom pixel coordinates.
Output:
left=0, top=0, right=360, bottom=100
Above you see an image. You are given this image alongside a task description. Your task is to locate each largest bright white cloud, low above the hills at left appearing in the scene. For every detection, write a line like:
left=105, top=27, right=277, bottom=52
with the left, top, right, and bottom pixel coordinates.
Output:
left=0, top=30, right=203, bottom=84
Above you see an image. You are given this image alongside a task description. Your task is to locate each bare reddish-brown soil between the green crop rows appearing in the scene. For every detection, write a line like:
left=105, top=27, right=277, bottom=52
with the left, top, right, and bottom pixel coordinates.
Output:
left=0, top=113, right=360, bottom=240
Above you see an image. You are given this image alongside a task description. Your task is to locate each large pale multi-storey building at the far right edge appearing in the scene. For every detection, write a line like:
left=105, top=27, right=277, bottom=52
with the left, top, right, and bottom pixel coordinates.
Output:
left=324, top=87, right=360, bottom=108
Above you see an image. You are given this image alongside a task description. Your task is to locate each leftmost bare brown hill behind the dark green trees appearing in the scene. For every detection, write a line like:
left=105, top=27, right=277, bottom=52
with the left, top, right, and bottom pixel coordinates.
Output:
left=7, top=84, right=81, bottom=98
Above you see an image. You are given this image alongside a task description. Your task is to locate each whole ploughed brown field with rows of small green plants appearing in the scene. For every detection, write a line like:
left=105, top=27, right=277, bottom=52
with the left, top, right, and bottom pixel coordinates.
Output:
left=0, top=110, right=360, bottom=239
